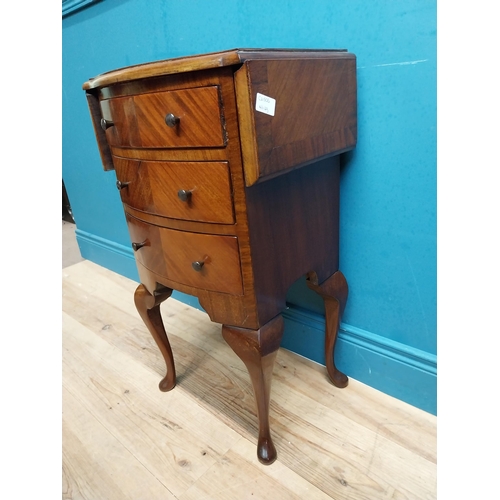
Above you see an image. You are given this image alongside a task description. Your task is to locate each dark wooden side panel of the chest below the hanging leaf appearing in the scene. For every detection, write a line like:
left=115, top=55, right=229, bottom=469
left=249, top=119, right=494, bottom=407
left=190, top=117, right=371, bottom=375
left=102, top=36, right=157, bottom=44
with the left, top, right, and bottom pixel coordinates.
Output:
left=247, top=157, right=339, bottom=322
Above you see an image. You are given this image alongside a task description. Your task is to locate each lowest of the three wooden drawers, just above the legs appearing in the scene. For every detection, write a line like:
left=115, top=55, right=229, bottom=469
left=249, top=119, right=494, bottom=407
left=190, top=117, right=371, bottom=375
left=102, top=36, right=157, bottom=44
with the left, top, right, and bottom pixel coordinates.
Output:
left=126, top=214, right=243, bottom=295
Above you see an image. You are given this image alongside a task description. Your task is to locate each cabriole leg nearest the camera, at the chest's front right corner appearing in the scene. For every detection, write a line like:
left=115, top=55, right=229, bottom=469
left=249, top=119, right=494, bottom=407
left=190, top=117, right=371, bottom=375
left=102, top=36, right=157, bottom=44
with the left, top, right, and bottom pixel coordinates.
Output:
left=222, top=315, right=284, bottom=465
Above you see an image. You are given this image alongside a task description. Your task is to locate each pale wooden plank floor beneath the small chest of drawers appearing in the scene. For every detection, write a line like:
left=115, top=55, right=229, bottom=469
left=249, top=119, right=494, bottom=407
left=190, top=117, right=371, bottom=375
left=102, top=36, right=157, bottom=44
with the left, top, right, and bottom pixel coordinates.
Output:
left=62, top=261, right=436, bottom=500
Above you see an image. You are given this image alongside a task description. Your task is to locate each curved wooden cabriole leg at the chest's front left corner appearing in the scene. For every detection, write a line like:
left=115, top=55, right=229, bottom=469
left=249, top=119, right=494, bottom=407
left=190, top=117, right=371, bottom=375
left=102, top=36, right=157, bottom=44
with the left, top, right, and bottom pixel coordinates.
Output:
left=134, top=285, right=175, bottom=392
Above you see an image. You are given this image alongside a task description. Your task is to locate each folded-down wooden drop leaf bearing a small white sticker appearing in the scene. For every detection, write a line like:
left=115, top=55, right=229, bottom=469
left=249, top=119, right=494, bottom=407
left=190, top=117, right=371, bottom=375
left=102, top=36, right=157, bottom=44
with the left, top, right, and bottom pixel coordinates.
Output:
left=235, top=56, right=357, bottom=186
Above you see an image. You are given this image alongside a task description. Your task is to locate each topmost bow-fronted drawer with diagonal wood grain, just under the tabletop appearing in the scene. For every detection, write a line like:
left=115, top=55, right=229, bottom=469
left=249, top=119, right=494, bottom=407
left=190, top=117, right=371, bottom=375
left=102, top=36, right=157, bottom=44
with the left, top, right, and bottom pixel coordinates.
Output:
left=101, top=85, right=226, bottom=148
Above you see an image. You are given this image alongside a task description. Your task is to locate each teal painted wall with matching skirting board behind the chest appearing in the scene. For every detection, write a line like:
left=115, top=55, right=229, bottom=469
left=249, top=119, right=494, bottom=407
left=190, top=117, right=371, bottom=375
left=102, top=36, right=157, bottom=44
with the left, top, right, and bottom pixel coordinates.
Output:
left=62, top=0, right=436, bottom=413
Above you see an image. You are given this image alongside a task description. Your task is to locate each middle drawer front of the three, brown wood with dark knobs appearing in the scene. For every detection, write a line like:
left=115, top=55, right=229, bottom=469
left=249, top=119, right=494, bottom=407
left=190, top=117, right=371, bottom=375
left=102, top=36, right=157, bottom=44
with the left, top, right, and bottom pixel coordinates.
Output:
left=114, top=158, right=234, bottom=224
